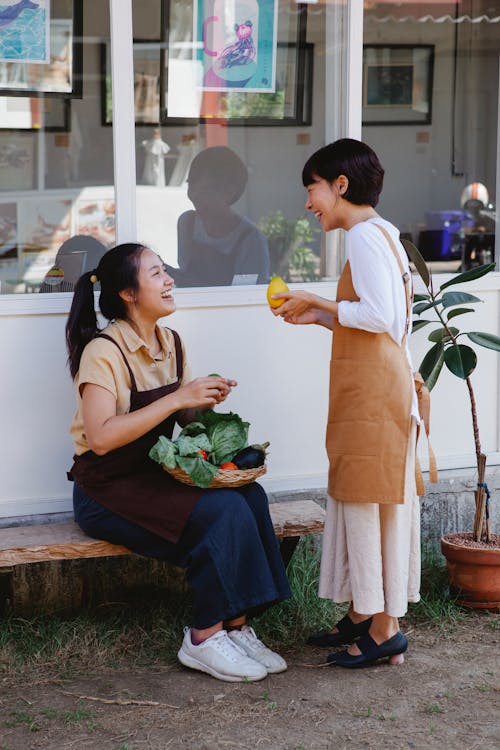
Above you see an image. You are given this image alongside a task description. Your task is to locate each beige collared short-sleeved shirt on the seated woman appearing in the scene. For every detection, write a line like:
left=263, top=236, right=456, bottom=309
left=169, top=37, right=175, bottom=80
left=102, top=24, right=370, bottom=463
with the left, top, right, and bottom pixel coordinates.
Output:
left=70, top=320, right=192, bottom=455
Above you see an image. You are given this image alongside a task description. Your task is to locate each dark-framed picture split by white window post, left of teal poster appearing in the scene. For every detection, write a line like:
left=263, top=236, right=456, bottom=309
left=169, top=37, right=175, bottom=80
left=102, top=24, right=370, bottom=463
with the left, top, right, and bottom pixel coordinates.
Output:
left=101, top=39, right=165, bottom=125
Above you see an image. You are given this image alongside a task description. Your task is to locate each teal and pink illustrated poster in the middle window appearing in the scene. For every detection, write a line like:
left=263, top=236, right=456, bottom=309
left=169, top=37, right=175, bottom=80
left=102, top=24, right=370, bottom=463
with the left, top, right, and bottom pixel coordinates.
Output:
left=195, top=0, right=278, bottom=92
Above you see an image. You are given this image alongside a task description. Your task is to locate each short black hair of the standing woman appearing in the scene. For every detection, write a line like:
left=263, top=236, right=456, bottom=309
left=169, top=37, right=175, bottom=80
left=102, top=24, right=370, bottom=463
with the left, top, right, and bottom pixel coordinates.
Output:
left=302, top=138, right=384, bottom=207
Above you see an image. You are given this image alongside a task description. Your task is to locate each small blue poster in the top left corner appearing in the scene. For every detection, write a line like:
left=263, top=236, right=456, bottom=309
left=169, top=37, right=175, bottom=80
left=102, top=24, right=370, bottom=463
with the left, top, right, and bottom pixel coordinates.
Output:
left=0, top=0, right=50, bottom=63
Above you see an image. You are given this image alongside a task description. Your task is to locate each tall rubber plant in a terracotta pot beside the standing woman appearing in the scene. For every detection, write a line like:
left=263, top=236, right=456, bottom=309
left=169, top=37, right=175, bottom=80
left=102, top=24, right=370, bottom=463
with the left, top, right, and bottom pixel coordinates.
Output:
left=403, top=240, right=500, bottom=609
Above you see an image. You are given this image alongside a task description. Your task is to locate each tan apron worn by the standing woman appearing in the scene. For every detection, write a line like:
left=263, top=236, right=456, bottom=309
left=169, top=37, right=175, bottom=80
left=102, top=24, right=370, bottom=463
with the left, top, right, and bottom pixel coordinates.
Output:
left=326, top=261, right=413, bottom=504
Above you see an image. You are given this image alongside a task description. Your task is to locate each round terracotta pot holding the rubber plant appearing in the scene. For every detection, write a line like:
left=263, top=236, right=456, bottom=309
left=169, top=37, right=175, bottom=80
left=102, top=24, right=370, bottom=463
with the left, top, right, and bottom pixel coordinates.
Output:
left=441, top=534, right=500, bottom=611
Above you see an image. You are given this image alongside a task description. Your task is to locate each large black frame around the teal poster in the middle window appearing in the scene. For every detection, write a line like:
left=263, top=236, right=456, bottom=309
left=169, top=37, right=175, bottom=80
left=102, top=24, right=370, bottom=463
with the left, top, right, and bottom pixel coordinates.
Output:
left=160, top=0, right=313, bottom=126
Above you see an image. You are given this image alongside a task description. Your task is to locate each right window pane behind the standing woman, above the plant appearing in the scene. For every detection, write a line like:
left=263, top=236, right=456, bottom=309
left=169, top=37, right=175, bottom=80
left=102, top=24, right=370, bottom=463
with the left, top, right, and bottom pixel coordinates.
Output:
left=363, top=0, right=500, bottom=272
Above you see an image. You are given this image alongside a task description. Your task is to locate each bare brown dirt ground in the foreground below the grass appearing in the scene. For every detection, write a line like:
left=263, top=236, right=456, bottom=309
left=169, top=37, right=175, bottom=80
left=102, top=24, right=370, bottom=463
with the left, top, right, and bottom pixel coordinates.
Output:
left=0, top=616, right=500, bottom=750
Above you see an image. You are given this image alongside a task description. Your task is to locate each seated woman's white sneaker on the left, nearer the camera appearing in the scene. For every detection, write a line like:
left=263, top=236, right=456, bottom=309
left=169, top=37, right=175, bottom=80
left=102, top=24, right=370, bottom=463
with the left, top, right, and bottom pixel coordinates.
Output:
left=177, top=628, right=267, bottom=682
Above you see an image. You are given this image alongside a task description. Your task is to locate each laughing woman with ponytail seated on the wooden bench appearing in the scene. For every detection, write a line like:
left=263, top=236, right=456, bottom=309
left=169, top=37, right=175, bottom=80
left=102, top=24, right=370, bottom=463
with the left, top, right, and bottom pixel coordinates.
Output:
left=66, top=243, right=290, bottom=682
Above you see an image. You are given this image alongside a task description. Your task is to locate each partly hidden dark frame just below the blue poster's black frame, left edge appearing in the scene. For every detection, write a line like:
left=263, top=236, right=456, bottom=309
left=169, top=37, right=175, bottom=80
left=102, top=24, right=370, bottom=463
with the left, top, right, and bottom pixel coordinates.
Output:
left=0, top=96, right=71, bottom=133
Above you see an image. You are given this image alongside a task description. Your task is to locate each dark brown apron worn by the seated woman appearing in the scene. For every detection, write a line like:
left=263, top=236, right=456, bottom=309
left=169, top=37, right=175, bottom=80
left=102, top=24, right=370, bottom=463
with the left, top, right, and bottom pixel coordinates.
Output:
left=68, top=331, right=203, bottom=542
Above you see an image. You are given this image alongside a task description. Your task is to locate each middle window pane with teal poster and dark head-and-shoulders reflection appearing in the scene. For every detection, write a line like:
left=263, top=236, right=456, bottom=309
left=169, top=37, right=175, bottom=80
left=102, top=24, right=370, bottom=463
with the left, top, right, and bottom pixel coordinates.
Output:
left=133, top=0, right=345, bottom=287
